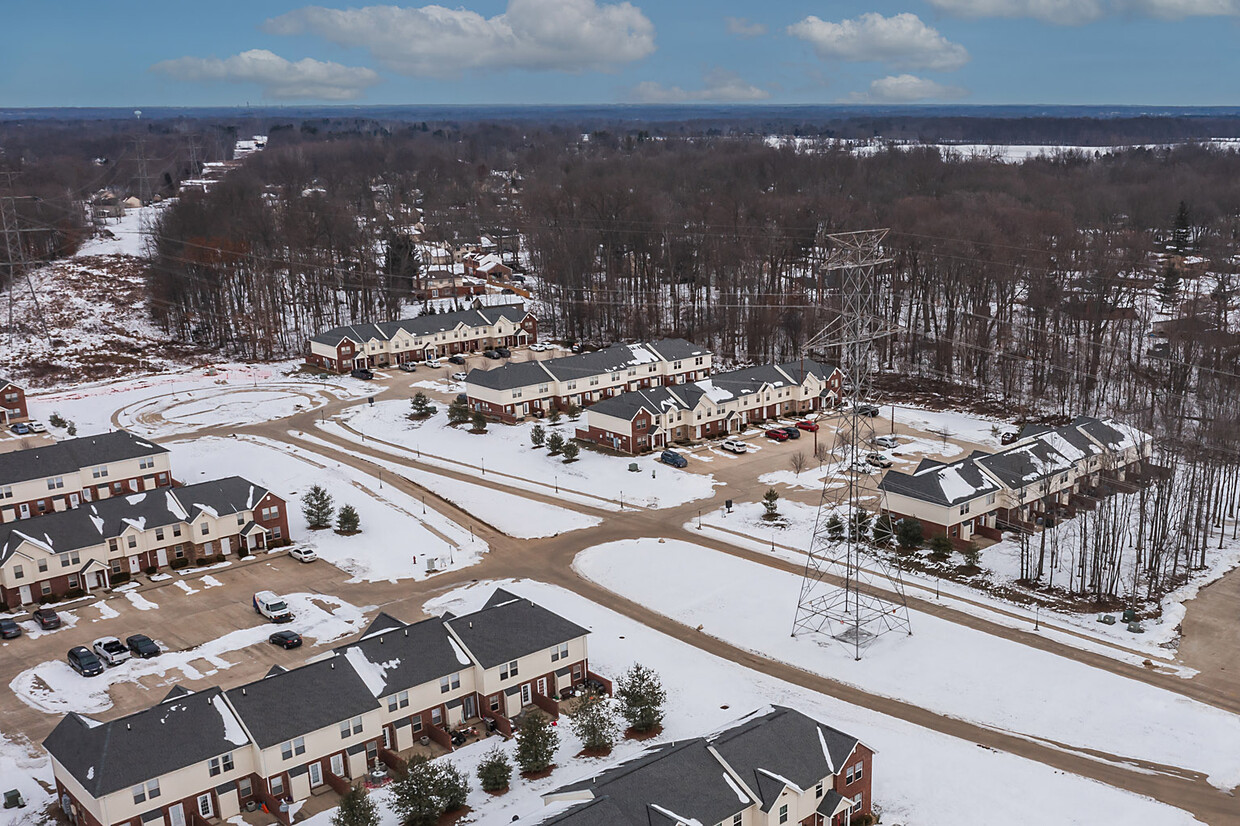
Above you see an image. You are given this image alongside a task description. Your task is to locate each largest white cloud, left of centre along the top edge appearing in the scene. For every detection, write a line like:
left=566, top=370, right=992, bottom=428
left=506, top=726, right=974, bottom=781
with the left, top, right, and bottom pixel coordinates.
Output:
left=264, top=0, right=655, bottom=77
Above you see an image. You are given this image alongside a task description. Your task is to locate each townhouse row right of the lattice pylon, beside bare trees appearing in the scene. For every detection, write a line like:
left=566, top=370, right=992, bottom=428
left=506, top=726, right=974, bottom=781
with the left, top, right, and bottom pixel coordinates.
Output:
left=879, top=417, right=1153, bottom=547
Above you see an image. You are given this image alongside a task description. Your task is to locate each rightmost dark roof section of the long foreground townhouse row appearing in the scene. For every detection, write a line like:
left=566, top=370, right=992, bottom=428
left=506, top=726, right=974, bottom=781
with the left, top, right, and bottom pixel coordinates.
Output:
left=448, top=588, right=589, bottom=668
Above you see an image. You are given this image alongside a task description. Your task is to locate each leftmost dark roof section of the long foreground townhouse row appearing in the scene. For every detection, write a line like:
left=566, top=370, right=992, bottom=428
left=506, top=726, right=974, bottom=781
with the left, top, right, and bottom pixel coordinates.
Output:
left=43, top=687, right=249, bottom=797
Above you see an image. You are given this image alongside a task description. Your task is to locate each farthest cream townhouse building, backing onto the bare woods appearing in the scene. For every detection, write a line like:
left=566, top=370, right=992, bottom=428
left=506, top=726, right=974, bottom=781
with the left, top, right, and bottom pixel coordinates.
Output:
left=306, top=304, right=538, bottom=373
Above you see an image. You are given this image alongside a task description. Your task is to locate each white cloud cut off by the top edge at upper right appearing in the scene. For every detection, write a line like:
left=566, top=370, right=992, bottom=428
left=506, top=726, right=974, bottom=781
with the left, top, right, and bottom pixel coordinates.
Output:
left=929, top=0, right=1240, bottom=26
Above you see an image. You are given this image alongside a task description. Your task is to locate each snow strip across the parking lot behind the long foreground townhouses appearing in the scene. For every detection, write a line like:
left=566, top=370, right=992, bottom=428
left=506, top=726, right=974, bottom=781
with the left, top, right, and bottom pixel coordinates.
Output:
left=9, top=593, right=373, bottom=714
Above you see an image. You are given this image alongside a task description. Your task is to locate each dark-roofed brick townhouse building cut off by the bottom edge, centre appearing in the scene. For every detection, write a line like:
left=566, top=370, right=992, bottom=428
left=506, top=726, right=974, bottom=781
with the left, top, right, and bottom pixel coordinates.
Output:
left=542, top=706, right=874, bottom=826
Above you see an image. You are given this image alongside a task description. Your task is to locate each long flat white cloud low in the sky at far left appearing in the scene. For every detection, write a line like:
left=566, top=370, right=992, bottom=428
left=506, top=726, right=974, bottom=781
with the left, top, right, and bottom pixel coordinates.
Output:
left=151, top=48, right=379, bottom=100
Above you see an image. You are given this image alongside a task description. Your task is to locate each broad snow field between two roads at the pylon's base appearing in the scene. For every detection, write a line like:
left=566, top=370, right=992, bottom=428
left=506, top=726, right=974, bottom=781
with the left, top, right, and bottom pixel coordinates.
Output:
left=574, top=540, right=1240, bottom=789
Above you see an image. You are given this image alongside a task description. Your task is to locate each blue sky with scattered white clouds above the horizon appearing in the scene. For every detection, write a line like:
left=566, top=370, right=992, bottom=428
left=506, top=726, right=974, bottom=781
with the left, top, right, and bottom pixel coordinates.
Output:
left=0, top=0, right=1240, bottom=107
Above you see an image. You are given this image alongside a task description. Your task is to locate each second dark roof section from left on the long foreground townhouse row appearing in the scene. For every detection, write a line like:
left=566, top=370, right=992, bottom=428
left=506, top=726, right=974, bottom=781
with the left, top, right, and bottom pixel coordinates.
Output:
left=227, top=657, right=379, bottom=749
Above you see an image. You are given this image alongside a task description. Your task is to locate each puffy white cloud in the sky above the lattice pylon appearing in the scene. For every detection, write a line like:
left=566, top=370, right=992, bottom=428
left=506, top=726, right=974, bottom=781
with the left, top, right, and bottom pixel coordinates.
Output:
left=787, top=11, right=968, bottom=71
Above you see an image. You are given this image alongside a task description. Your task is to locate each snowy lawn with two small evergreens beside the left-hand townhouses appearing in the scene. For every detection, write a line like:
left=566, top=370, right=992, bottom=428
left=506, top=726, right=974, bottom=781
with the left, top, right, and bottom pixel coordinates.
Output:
left=169, top=437, right=487, bottom=582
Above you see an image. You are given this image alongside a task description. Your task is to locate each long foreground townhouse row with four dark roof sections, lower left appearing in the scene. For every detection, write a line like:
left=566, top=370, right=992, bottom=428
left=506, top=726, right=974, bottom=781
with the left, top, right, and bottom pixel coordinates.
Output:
left=43, top=589, right=589, bottom=826
